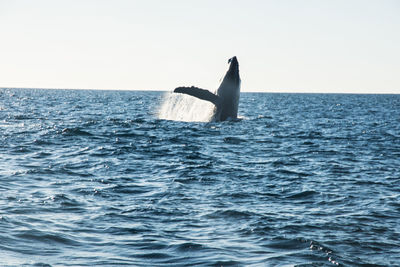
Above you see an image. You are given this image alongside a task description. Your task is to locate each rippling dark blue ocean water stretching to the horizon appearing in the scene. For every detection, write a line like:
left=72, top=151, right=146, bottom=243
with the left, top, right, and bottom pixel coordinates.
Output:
left=0, top=89, right=400, bottom=266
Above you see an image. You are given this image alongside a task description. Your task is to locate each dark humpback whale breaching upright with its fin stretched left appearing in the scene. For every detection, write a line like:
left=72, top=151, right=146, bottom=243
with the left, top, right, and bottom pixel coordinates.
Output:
left=174, top=57, right=240, bottom=121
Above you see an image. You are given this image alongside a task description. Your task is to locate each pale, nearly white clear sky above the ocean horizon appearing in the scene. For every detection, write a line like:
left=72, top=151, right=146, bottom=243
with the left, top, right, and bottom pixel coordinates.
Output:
left=0, top=0, right=400, bottom=93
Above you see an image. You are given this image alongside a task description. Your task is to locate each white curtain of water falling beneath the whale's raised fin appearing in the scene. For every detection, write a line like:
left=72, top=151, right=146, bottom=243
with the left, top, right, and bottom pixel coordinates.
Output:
left=158, top=92, right=214, bottom=122
